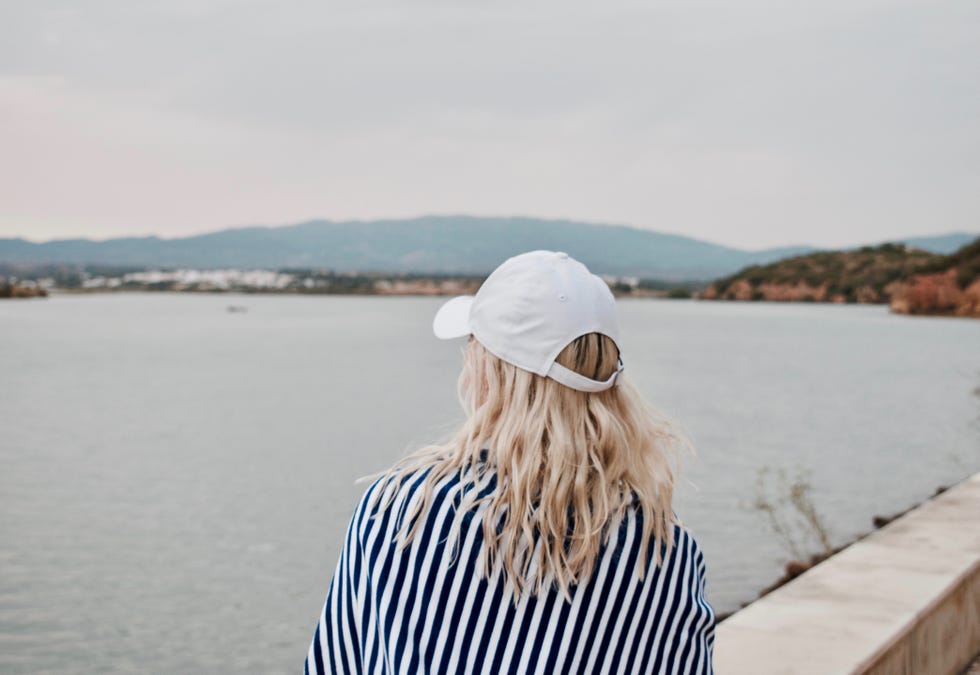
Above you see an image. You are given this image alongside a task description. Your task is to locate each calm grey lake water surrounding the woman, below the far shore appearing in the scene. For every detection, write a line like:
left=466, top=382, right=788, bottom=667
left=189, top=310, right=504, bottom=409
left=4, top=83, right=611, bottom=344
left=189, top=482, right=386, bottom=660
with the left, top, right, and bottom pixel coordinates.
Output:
left=0, top=294, right=980, bottom=673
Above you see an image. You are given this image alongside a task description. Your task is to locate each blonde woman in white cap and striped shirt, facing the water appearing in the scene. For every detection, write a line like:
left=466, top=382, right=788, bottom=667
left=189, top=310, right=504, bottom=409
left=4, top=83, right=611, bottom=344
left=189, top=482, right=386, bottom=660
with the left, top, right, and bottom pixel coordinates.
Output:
left=306, top=251, right=715, bottom=675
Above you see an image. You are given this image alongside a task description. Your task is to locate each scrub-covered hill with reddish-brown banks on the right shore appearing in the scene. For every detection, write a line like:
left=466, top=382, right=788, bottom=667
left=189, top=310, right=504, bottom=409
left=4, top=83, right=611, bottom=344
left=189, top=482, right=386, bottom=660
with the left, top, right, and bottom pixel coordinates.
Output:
left=701, top=237, right=980, bottom=316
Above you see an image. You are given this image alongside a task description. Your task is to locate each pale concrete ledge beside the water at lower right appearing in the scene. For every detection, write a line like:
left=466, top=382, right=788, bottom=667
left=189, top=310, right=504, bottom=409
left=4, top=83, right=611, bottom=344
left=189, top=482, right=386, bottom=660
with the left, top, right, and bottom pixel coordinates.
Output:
left=714, top=473, right=980, bottom=675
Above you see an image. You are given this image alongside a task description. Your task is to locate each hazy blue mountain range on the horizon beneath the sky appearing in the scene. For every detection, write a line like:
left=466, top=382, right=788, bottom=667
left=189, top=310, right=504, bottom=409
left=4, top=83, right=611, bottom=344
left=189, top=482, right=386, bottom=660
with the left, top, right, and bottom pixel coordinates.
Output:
left=0, top=216, right=976, bottom=280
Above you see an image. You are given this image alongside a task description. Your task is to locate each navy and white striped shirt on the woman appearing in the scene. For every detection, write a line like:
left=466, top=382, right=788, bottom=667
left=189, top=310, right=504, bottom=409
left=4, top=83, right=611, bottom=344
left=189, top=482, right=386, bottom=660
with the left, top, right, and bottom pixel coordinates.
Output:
left=306, top=469, right=715, bottom=675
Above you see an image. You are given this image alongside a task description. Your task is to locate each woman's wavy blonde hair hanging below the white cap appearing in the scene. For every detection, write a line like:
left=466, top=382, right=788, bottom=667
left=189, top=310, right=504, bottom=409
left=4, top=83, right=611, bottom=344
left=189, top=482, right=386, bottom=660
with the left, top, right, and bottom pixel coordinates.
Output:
left=375, top=333, right=688, bottom=601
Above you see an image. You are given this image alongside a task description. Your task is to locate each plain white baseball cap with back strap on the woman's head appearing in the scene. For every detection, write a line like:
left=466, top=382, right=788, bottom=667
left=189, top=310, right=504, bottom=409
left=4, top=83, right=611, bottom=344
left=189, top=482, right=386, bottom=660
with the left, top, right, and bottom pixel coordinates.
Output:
left=432, top=251, right=623, bottom=392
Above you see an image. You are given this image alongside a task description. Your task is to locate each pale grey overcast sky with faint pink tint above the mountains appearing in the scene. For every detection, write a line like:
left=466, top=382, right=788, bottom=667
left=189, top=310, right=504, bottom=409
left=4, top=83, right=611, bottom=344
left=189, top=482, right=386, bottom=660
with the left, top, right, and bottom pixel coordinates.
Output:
left=0, top=0, right=980, bottom=248
